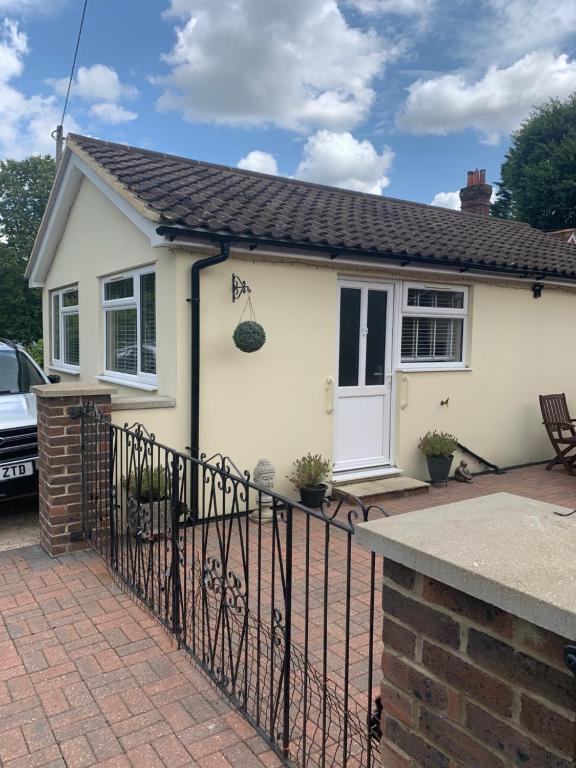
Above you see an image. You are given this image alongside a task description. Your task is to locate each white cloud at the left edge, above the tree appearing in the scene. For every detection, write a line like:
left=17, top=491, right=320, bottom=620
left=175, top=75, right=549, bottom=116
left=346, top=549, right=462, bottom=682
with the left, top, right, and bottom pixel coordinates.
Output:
left=0, top=20, right=78, bottom=160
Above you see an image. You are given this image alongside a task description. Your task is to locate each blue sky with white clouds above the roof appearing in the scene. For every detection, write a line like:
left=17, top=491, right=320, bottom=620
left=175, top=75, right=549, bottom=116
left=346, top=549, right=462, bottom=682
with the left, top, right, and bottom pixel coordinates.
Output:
left=0, top=0, right=576, bottom=205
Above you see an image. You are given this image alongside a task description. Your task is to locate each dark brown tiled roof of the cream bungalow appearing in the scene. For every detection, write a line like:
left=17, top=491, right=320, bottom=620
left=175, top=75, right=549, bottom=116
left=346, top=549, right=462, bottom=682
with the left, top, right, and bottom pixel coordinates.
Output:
left=69, top=134, right=576, bottom=279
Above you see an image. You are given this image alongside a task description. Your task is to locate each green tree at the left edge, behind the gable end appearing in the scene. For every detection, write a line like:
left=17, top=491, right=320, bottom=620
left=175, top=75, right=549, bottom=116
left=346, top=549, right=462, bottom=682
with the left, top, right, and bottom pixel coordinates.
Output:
left=0, top=155, right=54, bottom=343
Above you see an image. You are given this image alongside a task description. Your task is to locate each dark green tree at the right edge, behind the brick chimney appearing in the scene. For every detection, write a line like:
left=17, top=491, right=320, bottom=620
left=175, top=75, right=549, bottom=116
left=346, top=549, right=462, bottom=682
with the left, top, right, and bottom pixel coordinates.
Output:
left=491, top=94, right=576, bottom=230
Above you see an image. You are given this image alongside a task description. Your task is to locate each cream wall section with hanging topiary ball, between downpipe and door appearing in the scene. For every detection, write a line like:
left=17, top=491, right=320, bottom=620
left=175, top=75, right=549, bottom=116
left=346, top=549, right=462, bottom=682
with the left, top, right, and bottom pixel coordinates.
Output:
left=195, top=259, right=337, bottom=493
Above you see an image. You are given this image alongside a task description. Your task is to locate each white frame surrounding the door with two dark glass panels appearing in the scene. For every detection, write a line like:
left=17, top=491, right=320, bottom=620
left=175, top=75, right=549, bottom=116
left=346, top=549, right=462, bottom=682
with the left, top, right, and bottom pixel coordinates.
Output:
left=333, top=275, right=401, bottom=479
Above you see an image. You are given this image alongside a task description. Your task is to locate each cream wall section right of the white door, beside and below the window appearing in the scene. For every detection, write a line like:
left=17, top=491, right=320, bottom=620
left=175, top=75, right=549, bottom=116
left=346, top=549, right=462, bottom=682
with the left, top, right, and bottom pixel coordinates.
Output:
left=396, top=283, right=576, bottom=478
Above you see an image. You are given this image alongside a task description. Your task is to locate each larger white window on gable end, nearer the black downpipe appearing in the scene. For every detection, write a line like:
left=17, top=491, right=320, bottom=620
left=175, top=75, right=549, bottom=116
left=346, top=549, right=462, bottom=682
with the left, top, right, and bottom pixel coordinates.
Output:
left=102, top=267, right=157, bottom=386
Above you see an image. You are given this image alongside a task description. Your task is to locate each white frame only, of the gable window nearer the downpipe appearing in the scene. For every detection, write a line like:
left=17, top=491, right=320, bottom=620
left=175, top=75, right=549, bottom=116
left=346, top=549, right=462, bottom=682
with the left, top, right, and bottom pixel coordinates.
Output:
left=101, top=266, right=158, bottom=389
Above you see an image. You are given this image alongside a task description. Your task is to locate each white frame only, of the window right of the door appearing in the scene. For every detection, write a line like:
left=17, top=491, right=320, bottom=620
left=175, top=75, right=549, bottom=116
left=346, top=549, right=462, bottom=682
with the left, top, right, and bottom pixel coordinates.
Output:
left=398, top=282, right=470, bottom=372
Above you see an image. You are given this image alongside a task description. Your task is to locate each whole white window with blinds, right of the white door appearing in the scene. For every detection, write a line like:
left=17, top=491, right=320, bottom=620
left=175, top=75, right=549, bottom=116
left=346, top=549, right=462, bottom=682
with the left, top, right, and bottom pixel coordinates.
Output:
left=400, top=283, right=468, bottom=370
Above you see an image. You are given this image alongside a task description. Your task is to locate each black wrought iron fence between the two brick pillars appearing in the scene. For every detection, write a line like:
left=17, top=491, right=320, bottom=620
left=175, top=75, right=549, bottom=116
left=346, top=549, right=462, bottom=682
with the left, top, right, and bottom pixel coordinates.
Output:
left=81, top=406, right=384, bottom=768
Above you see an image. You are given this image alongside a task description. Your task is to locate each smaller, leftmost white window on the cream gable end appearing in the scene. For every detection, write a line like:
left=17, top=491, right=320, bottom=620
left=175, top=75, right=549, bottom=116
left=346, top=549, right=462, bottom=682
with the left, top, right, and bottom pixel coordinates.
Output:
left=50, top=285, right=80, bottom=373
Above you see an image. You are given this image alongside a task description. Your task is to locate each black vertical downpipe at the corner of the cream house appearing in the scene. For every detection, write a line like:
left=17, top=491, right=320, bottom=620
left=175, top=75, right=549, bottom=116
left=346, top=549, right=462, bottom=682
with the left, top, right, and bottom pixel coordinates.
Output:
left=187, top=243, right=230, bottom=513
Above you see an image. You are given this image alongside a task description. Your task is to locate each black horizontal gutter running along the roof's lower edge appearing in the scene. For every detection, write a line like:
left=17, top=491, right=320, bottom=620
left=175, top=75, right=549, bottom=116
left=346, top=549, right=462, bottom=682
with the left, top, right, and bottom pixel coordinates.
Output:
left=156, top=225, right=576, bottom=282
